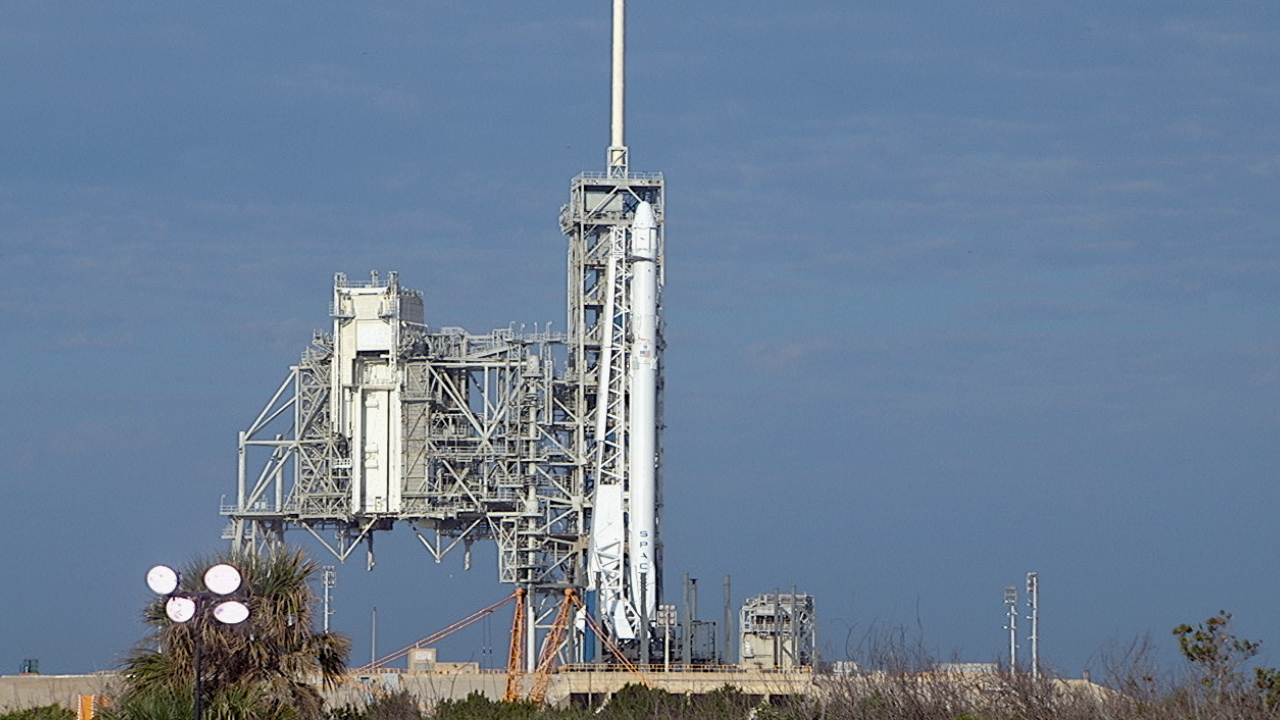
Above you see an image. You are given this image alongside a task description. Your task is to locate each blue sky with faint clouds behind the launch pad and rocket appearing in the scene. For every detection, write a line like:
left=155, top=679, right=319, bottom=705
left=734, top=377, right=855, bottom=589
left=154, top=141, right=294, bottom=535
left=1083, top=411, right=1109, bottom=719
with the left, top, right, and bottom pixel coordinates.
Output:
left=0, top=0, right=1280, bottom=675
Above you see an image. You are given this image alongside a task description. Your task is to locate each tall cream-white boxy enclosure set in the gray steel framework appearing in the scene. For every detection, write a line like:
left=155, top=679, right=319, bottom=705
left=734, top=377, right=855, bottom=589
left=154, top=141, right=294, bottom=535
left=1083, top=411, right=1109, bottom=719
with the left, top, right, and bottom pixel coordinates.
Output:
left=329, top=273, right=422, bottom=515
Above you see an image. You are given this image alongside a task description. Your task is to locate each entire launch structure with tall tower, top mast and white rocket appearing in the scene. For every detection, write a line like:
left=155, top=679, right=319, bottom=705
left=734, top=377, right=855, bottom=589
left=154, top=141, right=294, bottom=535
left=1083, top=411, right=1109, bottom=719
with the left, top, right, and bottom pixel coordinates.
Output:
left=223, top=0, right=664, bottom=665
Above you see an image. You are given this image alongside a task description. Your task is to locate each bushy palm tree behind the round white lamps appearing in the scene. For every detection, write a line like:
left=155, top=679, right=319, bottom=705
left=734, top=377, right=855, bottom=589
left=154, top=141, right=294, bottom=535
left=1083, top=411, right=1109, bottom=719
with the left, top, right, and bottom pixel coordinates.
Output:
left=115, top=548, right=351, bottom=720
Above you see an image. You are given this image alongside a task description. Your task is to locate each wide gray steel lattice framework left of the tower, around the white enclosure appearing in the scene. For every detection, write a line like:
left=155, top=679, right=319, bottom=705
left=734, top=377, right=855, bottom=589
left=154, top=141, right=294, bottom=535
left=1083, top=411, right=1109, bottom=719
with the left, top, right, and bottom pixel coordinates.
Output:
left=223, top=275, right=585, bottom=655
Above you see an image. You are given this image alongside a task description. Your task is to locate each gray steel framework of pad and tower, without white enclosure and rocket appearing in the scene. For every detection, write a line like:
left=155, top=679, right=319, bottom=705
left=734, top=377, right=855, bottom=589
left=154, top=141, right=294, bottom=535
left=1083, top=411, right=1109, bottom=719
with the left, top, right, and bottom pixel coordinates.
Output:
left=221, top=173, right=663, bottom=656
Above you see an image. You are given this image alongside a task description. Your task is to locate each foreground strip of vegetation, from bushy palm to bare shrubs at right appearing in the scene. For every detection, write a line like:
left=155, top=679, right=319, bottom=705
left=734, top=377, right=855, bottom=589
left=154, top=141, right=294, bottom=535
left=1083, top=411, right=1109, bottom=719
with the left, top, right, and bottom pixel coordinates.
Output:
left=10, top=550, right=1280, bottom=720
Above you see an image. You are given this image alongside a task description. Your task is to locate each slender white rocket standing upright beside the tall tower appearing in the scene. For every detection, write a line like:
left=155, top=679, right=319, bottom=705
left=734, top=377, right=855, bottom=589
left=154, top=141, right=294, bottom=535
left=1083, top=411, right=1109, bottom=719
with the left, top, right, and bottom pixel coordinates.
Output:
left=627, top=202, right=658, bottom=621
